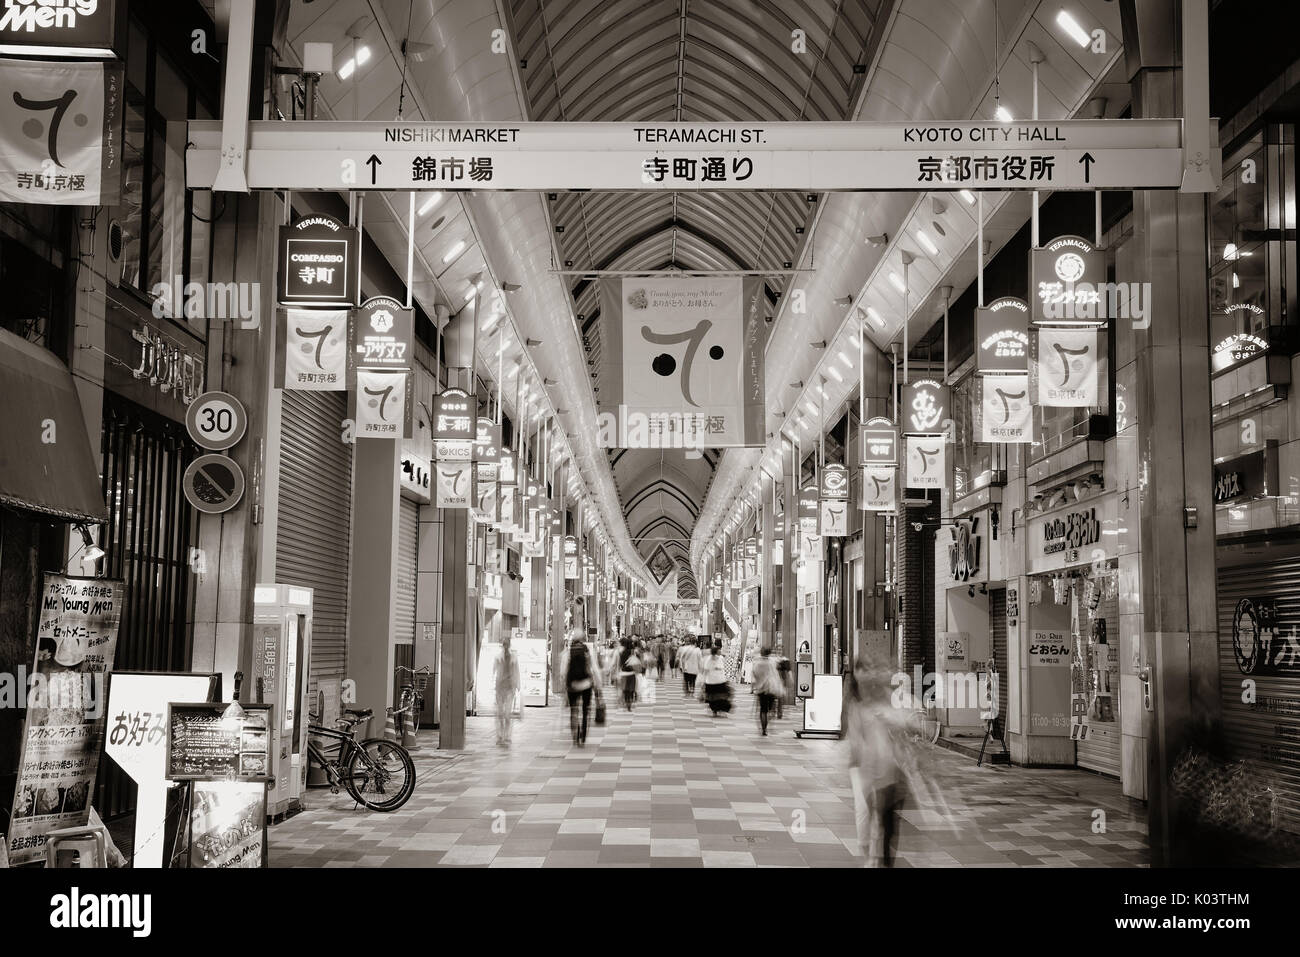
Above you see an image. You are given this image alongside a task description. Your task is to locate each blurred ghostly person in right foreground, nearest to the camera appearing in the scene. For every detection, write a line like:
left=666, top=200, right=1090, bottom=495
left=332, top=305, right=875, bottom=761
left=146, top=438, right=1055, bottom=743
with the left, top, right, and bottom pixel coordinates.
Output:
left=840, top=657, right=907, bottom=867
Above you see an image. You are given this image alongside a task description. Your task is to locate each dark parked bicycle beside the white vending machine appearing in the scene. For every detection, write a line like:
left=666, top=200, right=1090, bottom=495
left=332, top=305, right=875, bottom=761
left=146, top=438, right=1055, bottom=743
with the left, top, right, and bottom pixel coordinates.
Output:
left=307, top=707, right=415, bottom=811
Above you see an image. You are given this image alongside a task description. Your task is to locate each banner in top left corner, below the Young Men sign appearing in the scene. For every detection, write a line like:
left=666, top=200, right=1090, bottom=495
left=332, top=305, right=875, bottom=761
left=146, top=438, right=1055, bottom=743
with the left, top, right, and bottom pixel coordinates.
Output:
left=0, top=59, right=126, bottom=207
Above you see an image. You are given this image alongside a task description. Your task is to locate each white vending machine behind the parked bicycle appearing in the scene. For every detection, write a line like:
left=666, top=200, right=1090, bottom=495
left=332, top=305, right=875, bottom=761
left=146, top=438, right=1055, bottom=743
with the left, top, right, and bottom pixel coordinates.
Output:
left=244, top=585, right=312, bottom=818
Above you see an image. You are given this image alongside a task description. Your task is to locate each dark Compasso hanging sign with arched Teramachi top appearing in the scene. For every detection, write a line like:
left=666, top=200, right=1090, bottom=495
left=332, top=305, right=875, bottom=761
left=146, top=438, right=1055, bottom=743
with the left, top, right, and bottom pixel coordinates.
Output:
left=276, top=216, right=360, bottom=306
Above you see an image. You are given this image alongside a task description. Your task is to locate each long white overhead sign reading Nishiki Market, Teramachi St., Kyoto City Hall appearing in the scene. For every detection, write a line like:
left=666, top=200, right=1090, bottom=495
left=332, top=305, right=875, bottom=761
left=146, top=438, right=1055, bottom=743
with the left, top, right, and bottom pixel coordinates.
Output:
left=186, top=118, right=1217, bottom=192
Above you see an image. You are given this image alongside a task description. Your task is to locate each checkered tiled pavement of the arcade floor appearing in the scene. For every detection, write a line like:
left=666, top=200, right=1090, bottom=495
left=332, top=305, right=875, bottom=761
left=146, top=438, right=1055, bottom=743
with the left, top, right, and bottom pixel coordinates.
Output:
left=270, top=679, right=1147, bottom=867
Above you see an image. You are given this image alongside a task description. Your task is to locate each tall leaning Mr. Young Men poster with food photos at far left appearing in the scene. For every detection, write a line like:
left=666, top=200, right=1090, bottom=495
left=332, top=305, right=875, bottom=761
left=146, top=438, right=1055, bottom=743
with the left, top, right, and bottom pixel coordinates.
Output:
left=8, top=575, right=122, bottom=865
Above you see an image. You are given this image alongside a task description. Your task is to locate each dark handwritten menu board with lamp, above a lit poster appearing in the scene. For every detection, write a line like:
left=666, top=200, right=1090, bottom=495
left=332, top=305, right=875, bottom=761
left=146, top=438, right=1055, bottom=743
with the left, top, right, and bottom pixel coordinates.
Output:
left=166, top=702, right=270, bottom=781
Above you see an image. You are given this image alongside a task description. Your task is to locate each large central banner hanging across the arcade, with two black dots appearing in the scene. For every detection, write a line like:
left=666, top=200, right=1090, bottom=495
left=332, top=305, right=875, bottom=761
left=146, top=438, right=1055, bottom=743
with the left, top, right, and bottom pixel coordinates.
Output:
left=597, top=277, right=767, bottom=449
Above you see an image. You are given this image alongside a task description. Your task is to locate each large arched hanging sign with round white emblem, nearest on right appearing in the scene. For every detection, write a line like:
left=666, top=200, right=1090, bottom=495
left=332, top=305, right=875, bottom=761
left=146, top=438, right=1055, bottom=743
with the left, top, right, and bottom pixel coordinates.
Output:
left=1030, top=235, right=1110, bottom=325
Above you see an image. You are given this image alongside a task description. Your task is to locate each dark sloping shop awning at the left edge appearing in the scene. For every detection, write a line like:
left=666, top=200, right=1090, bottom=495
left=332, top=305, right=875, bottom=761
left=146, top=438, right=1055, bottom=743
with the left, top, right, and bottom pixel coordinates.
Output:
left=0, top=329, right=108, bottom=523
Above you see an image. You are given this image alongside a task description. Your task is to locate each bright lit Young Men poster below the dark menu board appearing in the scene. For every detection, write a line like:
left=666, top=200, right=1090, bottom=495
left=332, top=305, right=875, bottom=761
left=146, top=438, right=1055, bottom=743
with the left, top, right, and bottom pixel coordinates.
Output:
left=190, top=781, right=267, bottom=867
